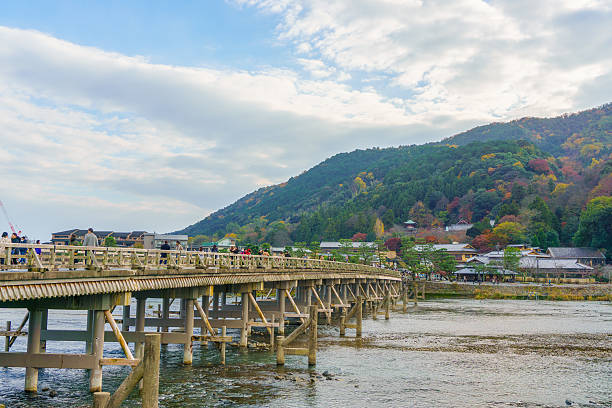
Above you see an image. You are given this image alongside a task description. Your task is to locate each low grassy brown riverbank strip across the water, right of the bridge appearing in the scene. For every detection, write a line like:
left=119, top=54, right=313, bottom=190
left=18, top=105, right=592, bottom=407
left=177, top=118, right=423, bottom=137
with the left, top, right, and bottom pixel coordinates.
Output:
left=425, top=281, right=612, bottom=301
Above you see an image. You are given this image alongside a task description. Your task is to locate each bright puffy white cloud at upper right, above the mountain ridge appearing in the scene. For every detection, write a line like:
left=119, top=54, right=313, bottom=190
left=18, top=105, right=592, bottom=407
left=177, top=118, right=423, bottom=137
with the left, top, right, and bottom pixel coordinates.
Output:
left=239, top=0, right=612, bottom=122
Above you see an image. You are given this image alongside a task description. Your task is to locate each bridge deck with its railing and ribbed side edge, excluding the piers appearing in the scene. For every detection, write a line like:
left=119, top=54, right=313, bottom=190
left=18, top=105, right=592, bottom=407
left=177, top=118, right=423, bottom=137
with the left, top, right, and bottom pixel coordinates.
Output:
left=0, top=244, right=400, bottom=302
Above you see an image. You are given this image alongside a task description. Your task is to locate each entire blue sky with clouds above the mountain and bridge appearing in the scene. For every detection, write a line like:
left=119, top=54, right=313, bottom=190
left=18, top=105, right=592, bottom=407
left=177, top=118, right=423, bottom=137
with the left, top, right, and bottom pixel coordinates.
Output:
left=0, top=0, right=612, bottom=242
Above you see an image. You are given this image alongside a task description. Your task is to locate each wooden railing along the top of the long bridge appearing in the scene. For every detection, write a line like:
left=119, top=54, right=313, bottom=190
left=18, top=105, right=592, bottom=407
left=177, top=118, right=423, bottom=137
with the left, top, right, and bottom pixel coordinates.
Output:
left=0, top=243, right=395, bottom=275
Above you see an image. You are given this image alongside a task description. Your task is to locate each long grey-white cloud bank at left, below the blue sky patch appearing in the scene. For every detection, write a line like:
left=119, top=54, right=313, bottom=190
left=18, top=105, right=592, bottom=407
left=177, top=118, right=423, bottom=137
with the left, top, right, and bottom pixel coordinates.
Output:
left=0, top=27, right=440, bottom=239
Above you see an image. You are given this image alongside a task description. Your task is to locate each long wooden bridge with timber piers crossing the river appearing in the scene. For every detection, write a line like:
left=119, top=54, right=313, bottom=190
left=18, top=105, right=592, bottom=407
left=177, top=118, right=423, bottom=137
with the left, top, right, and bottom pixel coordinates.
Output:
left=0, top=244, right=416, bottom=404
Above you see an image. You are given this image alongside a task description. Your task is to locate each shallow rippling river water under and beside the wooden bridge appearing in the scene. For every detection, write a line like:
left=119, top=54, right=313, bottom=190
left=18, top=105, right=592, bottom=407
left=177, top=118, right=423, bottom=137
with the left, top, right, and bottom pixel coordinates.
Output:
left=0, top=299, right=612, bottom=408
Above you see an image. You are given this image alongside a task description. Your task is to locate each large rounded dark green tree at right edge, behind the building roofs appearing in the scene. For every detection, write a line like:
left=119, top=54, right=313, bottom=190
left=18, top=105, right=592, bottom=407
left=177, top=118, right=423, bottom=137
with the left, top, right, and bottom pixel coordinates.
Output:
left=574, top=196, right=612, bottom=259
